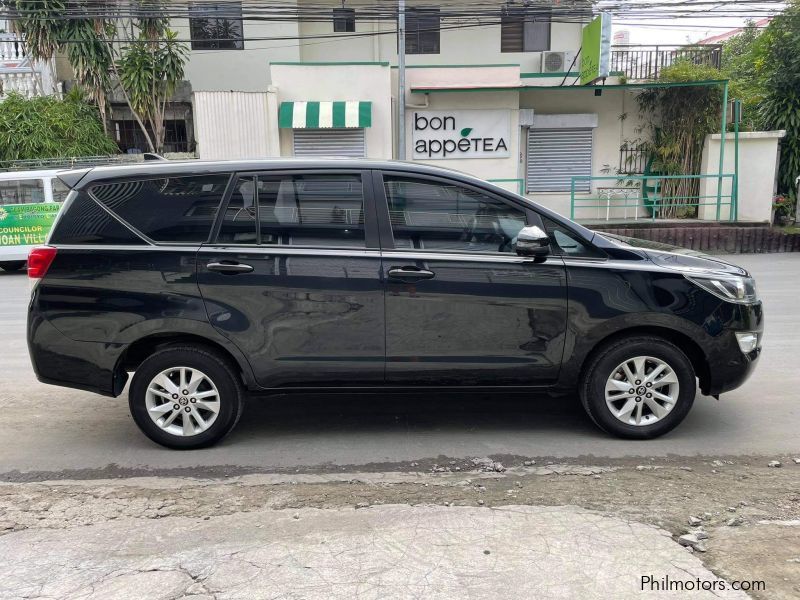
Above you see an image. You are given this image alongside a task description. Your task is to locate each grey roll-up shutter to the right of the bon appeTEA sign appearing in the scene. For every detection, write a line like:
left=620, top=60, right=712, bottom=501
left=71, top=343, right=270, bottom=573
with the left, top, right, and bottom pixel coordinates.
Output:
left=526, top=127, right=592, bottom=192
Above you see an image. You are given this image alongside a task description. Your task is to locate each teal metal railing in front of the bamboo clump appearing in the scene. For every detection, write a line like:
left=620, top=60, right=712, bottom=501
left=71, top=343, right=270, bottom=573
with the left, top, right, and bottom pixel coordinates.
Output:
left=570, top=173, right=737, bottom=222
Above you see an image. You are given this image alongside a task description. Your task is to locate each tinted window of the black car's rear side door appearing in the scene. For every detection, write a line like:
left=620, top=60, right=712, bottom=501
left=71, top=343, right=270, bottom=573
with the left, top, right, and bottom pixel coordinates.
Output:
left=218, top=173, right=366, bottom=248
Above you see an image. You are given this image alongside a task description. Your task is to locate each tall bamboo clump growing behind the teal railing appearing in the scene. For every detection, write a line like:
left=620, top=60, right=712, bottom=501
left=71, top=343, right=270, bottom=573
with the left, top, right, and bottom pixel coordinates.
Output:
left=636, top=59, right=722, bottom=217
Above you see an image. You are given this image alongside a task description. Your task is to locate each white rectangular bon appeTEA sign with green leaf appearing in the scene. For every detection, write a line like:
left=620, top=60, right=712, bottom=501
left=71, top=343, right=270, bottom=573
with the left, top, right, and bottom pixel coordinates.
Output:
left=411, top=109, right=511, bottom=160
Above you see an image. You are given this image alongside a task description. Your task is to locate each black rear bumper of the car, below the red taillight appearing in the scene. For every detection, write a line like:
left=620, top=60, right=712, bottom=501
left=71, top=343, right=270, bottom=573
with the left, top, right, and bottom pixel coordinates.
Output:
left=28, top=316, right=128, bottom=397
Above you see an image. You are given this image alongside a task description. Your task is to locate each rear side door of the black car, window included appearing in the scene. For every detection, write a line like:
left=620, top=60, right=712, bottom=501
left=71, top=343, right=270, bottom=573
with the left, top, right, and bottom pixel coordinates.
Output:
left=198, top=170, right=385, bottom=388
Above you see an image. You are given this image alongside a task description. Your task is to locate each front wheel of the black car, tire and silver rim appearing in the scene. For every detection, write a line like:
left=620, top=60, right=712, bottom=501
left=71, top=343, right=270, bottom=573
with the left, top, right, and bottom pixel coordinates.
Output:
left=579, top=336, right=697, bottom=439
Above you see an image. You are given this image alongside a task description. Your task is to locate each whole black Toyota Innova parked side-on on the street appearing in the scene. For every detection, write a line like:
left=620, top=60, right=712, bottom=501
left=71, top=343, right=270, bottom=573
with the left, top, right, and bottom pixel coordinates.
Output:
left=28, top=159, right=763, bottom=448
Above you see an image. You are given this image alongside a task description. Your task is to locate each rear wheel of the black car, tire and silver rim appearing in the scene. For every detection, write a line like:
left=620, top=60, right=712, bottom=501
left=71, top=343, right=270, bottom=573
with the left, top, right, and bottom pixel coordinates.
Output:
left=128, top=346, right=244, bottom=450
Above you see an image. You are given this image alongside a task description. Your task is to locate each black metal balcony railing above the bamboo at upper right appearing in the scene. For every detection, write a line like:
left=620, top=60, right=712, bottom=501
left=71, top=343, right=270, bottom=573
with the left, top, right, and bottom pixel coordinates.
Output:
left=611, top=44, right=722, bottom=81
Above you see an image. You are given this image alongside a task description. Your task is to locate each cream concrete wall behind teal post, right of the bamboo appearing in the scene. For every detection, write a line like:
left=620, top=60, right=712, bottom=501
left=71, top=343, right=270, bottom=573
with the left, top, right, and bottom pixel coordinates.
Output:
left=698, top=131, right=786, bottom=223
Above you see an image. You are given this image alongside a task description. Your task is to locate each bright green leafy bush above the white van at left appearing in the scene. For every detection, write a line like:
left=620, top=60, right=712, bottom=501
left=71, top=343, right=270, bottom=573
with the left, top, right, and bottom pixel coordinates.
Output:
left=0, top=93, right=118, bottom=162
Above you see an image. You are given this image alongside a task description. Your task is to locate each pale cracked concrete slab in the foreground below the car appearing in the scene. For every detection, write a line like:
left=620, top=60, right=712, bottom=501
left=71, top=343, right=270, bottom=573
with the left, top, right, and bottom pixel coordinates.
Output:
left=0, top=505, right=747, bottom=600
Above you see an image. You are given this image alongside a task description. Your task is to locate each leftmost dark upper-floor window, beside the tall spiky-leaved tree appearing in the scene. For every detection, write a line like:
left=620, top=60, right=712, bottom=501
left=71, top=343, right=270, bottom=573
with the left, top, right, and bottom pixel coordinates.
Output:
left=189, top=2, right=244, bottom=50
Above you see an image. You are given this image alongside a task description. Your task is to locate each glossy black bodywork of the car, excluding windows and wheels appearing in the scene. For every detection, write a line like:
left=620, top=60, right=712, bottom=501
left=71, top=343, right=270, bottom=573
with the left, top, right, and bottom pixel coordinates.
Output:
left=28, top=161, right=763, bottom=396
